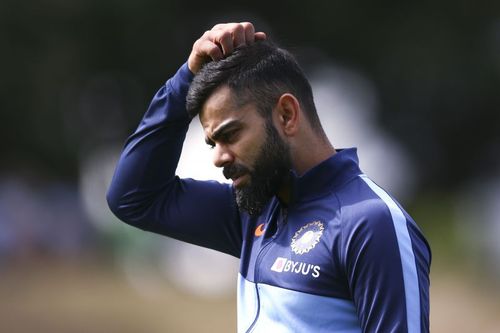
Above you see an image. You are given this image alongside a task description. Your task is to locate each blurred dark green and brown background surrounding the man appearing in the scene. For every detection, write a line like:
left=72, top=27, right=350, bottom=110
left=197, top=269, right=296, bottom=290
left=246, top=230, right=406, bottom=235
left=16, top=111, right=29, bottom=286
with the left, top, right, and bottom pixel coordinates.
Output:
left=0, top=0, right=500, bottom=332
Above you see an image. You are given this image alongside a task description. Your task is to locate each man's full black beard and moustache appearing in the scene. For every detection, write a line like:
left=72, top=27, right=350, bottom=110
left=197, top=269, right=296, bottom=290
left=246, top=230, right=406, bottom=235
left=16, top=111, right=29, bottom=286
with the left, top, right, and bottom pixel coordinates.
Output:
left=223, top=121, right=292, bottom=216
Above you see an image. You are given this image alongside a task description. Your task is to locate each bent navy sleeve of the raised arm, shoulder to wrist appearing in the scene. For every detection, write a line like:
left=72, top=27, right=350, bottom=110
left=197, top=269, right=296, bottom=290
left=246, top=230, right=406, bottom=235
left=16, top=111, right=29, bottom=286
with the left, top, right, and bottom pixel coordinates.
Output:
left=107, top=64, right=242, bottom=257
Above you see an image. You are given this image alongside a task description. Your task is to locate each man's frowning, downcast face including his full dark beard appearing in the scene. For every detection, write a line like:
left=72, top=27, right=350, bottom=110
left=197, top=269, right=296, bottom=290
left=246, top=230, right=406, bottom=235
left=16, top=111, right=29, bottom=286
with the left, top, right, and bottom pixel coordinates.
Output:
left=200, top=87, right=291, bottom=215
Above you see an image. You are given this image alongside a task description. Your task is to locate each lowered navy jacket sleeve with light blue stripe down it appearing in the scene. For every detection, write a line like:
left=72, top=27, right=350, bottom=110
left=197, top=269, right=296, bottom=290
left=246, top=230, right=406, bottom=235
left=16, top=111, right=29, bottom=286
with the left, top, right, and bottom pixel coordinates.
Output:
left=341, top=175, right=431, bottom=332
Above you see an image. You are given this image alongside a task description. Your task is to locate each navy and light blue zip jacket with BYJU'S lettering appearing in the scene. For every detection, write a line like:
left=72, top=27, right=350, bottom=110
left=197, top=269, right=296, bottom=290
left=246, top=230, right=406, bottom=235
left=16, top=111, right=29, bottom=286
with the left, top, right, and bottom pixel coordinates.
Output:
left=108, top=64, right=431, bottom=333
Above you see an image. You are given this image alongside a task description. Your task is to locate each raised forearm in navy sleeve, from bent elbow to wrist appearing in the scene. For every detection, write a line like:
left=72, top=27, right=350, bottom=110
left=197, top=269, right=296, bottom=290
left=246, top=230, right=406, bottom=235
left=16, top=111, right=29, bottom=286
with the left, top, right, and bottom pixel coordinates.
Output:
left=107, top=64, right=192, bottom=227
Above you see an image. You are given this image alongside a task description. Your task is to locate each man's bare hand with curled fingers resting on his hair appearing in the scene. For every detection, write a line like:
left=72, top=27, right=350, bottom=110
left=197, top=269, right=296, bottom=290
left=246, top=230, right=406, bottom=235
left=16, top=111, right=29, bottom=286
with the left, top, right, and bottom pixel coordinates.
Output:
left=188, top=22, right=266, bottom=73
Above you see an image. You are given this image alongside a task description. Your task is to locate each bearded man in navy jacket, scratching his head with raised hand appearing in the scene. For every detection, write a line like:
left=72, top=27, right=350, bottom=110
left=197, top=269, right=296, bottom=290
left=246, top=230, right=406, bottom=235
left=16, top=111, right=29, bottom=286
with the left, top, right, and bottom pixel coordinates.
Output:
left=108, top=22, right=430, bottom=333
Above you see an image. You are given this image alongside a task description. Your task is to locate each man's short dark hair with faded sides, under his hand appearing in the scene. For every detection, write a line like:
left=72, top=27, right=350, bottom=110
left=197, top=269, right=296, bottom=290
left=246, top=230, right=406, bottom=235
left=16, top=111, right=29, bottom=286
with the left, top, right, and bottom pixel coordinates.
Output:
left=186, top=41, right=321, bottom=128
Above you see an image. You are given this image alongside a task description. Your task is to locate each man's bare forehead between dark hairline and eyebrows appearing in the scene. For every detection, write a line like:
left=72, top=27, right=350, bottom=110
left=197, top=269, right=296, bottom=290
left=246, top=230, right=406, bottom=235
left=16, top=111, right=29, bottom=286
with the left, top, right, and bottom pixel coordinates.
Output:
left=200, top=86, right=261, bottom=134
